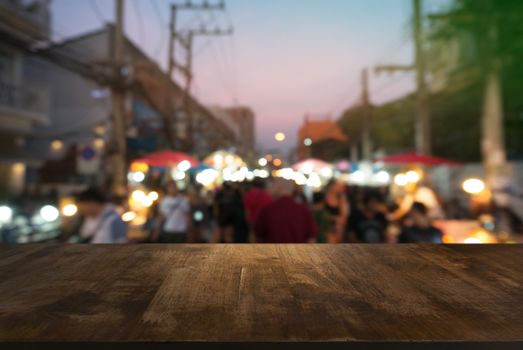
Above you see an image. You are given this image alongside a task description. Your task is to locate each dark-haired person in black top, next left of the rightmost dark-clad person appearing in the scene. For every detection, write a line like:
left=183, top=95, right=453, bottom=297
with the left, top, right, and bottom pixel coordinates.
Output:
left=348, top=192, right=389, bottom=243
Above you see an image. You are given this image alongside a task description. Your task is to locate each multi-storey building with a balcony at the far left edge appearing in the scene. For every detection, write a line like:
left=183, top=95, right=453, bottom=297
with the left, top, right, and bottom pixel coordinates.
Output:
left=0, top=0, right=50, bottom=196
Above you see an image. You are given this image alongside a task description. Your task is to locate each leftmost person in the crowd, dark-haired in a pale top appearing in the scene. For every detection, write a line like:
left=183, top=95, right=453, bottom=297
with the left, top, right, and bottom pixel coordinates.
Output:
left=76, top=189, right=127, bottom=244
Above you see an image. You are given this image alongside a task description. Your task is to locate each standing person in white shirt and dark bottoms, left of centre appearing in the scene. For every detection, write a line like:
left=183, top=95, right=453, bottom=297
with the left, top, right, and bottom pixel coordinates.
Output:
left=157, top=182, right=191, bottom=243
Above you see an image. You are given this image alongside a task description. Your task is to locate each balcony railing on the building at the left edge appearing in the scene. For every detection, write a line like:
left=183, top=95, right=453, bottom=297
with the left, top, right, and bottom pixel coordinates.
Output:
left=0, top=81, right=49, bottom=119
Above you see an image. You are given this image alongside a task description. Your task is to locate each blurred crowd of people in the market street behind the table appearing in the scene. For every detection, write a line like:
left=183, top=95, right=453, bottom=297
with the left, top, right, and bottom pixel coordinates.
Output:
left=70, top=178, right=450, bottom=243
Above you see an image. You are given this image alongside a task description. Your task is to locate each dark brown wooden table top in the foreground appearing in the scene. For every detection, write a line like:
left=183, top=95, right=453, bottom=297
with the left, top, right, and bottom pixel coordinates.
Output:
left=0, top=245, right=523, bottom=342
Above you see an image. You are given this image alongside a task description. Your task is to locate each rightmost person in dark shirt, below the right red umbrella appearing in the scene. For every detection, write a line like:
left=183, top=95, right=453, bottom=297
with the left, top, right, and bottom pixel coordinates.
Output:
left=398, top=202, right=443, bottom=243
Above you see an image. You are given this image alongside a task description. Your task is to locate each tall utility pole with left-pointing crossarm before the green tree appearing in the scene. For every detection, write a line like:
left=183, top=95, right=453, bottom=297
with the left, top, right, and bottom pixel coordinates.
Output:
left=376, top=0, right=432, bottom=154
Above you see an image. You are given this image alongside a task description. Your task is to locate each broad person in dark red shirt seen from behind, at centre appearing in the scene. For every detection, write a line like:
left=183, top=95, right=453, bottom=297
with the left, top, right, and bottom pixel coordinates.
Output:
left=254, top=179, right=318, bottom=243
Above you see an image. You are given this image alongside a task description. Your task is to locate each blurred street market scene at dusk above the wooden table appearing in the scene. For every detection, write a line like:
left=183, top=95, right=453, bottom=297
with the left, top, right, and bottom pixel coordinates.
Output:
left=0, top=0, right=523, bottom=244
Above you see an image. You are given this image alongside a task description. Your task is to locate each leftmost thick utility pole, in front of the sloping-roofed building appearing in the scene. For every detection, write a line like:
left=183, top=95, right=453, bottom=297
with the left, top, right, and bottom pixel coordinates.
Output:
left=110, top=0, right=127, bottom=195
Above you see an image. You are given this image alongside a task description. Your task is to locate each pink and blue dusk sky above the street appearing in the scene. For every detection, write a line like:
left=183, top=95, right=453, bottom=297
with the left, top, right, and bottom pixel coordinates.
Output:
left=53, top=0, right=445, bottom=149
